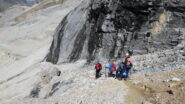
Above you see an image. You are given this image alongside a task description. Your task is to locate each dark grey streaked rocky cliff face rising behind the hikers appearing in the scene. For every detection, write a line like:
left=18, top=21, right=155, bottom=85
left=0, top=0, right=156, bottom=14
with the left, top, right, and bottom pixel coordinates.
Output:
left=46, top=0, right=185, bottom=64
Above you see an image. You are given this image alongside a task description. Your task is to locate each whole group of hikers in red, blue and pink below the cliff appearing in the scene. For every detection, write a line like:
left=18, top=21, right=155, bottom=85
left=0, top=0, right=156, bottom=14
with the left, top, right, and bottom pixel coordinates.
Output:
left=95, top=53, right=133, bottom=80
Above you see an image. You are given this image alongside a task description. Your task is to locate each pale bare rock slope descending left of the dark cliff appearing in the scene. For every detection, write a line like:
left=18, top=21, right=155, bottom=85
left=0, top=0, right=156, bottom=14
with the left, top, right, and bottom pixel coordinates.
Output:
left=0, top=0, right=81, bottom=103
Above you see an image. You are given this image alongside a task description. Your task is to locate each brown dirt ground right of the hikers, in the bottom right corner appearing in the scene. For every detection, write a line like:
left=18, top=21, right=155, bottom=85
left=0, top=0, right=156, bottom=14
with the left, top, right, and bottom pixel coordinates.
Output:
left=124, top=69, right=185, bottom=104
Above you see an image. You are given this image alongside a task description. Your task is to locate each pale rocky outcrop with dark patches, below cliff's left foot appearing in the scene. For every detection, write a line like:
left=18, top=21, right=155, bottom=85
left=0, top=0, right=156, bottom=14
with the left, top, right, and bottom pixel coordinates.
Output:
left=30, top=63, right=61, bottom=98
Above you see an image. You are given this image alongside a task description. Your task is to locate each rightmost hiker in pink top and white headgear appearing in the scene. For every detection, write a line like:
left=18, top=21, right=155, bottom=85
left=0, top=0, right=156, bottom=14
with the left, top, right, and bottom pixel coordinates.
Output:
left=124, top=53, right=133, bottom=78
